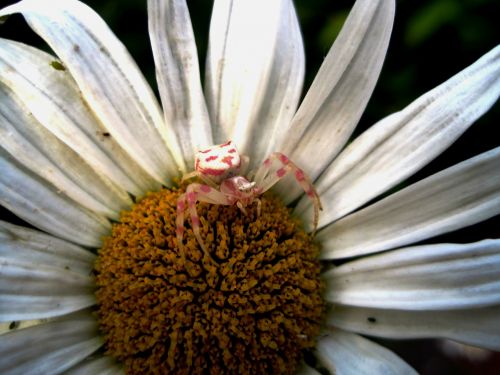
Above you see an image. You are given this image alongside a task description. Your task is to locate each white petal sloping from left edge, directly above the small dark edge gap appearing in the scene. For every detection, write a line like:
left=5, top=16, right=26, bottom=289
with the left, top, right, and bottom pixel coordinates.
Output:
left=0, top=148, right=111, bottom=247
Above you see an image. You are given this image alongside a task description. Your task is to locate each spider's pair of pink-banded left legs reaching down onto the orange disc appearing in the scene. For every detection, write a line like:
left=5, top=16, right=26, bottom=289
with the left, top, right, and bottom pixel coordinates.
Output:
left=175, top=183, right=231, bottom=264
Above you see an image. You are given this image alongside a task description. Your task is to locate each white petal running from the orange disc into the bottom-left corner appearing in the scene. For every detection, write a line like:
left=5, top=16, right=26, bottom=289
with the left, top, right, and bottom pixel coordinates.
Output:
left=0, top=311, right=103, bottom=375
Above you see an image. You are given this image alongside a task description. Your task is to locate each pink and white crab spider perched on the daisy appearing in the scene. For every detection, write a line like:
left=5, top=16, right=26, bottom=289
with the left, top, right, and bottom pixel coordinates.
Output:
left=176, top=141, right=322, bottom=259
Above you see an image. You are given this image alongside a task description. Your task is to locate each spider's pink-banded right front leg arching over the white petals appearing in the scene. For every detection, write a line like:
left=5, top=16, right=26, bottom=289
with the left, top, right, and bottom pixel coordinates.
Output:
left=254, top=152, right=323, bottom=235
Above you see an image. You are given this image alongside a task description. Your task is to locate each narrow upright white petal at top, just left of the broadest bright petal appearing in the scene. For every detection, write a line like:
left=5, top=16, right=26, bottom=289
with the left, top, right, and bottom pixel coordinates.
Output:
left=148, top=0, right=213, bottom=167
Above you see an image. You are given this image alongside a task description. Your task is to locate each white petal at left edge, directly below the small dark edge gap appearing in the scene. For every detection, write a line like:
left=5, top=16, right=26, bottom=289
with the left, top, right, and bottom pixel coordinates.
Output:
left=0, top=221, right=96, bottom=275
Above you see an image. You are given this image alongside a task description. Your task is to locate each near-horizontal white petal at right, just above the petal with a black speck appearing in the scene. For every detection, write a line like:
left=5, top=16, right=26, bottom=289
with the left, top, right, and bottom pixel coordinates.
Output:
left=323, top=240, right=500, bottom=310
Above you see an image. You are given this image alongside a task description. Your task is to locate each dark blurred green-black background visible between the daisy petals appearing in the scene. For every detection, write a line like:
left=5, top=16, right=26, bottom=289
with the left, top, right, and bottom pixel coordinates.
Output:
left=0, top=0, right=500, bottom=374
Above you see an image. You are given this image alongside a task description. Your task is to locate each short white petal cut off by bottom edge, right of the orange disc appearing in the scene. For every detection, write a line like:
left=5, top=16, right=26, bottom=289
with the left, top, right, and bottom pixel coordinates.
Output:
left=316, top=329, right=416, bottom=375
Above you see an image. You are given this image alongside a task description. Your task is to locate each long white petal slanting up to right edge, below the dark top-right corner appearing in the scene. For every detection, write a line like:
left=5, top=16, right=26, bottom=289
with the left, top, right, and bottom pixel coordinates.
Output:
left=296, top=47, right=500, bottom=227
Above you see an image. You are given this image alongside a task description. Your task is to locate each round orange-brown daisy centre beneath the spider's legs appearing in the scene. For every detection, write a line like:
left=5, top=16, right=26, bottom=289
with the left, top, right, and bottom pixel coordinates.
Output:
left=94, top=189, right=324, bottom=375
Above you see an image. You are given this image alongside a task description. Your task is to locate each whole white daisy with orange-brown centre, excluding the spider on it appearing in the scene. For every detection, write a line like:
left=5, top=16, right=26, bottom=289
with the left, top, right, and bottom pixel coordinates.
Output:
left=0, top=0, right=500, bottom=374
